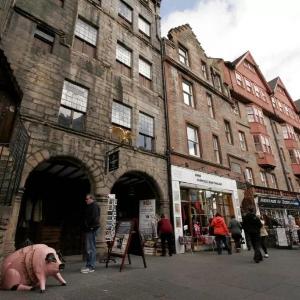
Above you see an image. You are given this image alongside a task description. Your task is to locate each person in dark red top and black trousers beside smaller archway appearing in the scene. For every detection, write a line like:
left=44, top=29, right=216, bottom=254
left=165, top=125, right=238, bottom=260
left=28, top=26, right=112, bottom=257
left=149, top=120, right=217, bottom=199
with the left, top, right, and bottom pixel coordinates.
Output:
left=157, top=214, right=174, bottom=256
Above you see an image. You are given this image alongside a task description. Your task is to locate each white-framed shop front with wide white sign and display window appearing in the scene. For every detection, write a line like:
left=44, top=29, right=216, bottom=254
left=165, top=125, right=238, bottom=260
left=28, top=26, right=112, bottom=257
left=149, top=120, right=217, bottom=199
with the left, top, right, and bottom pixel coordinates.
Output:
left=172, top=166, right=241, bottom=253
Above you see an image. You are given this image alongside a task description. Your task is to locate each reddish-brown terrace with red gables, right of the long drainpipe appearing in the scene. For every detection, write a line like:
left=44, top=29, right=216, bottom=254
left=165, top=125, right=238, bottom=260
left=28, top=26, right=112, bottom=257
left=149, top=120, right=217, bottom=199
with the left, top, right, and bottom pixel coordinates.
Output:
left=163, top=24, right=300, bottom=252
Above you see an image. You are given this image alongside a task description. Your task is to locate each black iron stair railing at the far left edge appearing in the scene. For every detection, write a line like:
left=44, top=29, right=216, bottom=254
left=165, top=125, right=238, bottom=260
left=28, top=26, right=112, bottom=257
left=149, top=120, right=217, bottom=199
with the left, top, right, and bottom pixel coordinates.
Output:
left=0, top=117, right=29, bottom=206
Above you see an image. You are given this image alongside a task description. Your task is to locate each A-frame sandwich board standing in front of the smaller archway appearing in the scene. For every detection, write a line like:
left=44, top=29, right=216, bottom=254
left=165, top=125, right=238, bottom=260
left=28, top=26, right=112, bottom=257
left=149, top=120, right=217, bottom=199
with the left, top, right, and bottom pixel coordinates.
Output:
left=106, top=220, right=147, bottom=272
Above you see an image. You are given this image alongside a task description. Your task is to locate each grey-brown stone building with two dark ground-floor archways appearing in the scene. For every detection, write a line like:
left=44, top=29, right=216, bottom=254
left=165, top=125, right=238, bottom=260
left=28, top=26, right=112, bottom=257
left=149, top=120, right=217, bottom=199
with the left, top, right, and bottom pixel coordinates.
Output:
left=0, top=0, right=169, bottom=255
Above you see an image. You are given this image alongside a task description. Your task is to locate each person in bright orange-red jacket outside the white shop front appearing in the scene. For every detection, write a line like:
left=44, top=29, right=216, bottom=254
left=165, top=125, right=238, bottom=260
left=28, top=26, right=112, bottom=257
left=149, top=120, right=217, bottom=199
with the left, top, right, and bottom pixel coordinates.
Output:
left=211, top=213, right=231, bottom=255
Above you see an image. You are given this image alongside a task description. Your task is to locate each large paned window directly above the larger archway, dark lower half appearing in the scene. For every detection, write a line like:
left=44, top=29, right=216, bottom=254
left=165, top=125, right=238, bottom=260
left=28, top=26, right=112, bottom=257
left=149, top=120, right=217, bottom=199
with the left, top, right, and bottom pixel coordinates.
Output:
left=58, top=80, right=88, bottom=130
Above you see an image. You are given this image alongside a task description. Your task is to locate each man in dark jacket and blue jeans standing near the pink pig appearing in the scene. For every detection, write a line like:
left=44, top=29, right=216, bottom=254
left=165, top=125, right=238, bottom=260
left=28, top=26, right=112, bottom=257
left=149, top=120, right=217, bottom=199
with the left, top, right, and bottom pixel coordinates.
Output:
left=81, top=194, right=100, bottom=274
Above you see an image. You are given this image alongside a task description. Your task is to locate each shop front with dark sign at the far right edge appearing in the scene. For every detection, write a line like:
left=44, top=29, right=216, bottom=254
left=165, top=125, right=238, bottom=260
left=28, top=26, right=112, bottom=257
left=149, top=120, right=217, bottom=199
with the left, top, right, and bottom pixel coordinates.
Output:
left=255, top=195, right=300, bottom=247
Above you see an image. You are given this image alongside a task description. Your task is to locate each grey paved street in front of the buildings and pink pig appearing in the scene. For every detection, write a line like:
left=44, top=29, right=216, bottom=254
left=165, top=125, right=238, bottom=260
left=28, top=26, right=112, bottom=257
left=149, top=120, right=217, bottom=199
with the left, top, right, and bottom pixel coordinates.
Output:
left=0, top=249, right=300, bottom=300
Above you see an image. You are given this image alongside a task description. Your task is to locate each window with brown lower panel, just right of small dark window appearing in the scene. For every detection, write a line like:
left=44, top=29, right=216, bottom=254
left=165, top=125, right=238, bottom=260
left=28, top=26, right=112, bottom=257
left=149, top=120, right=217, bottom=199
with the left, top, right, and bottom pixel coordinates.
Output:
left=73, top=18, right=98, bottom=57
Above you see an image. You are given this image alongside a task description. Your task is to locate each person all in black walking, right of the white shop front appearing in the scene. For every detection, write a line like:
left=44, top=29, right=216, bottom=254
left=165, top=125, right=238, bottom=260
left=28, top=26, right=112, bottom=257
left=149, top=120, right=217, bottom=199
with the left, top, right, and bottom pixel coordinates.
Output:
left=243, top=207, right=263, bottom=263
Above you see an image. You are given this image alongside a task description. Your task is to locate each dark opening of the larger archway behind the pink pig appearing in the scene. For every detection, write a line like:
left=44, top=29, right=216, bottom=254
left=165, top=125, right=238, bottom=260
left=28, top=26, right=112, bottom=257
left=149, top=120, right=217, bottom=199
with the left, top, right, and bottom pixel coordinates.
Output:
left=16, top=158, right=91, bottom=255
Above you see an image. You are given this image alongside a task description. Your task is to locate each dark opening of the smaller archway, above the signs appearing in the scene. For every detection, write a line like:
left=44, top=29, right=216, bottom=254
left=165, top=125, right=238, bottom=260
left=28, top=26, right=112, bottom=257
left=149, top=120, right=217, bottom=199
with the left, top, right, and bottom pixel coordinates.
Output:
left=111, top=171, right=160, bottom=220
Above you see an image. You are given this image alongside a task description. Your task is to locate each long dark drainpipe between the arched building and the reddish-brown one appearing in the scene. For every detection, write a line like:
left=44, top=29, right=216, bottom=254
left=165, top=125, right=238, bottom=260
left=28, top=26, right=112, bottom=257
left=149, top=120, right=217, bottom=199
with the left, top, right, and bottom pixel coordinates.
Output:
left=155, top=6, right=175, bottom=224
